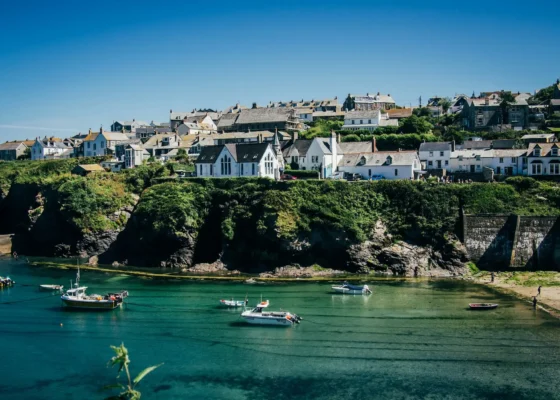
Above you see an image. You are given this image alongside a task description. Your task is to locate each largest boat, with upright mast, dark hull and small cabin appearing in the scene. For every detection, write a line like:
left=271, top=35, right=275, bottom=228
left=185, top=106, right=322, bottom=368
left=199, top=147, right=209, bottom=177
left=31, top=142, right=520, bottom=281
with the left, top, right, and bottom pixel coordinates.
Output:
left=60, top=266, right=128, bottom=310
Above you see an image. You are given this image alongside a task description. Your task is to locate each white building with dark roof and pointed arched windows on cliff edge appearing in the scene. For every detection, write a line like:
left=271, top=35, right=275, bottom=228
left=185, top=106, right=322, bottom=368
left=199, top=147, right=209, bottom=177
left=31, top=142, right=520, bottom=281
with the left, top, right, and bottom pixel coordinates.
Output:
left=195, top=143, right=281, bottom=179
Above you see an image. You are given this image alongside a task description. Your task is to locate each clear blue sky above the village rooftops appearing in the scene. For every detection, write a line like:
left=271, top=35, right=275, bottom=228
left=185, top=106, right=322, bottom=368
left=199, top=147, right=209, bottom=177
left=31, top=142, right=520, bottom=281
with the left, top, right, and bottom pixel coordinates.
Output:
left=0, top=0, right=560, bottom=142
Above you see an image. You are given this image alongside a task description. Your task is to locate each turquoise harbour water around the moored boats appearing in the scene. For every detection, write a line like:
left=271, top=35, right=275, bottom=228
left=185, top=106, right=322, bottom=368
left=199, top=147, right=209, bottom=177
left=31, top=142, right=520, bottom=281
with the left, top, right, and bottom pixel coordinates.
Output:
left=0, top=260, right=560, bottom=400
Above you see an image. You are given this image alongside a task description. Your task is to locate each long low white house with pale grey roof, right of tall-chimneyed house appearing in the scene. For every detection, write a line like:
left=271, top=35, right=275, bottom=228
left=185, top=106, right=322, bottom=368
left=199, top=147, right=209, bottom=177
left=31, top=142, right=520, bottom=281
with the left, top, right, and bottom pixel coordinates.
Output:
left=338, top=151, right=421, bottom=180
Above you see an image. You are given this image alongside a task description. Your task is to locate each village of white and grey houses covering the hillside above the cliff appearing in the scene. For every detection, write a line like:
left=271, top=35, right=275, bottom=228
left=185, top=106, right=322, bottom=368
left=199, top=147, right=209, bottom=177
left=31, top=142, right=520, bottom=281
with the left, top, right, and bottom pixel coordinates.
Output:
left=0, top=80, right=560, bottom=181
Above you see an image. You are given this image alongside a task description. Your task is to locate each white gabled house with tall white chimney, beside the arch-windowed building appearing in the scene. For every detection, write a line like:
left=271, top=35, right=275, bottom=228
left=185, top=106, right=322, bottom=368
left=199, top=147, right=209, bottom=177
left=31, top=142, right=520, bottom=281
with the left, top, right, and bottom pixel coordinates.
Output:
left=283, top=132, right=342, bottom=178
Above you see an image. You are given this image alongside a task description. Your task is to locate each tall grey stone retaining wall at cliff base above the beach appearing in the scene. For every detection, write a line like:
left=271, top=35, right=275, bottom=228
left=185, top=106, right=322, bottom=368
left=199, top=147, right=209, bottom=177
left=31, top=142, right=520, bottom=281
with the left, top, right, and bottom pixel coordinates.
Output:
left=463, top=215, right=560, bottom=270
